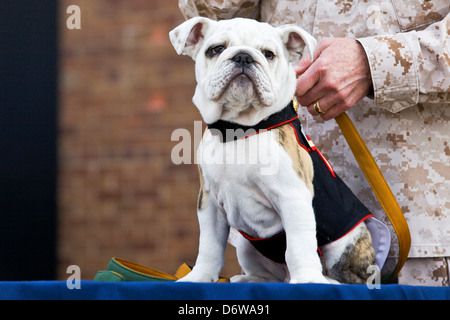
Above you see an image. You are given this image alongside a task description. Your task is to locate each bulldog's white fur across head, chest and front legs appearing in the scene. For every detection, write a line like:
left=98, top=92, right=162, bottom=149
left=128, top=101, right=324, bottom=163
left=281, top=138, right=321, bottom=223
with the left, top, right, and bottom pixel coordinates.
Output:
left=170, top=17, right=356, bottom=283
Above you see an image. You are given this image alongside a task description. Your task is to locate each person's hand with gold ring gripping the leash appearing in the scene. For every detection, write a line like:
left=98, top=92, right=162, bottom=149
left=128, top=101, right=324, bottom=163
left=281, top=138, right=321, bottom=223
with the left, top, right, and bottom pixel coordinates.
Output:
left=294, top=38, right=372, bottom=120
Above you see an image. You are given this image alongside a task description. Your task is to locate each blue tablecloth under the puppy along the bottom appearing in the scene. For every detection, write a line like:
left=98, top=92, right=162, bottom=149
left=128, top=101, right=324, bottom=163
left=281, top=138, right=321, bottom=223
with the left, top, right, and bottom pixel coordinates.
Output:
left=0, top=281, right=450, bottom=300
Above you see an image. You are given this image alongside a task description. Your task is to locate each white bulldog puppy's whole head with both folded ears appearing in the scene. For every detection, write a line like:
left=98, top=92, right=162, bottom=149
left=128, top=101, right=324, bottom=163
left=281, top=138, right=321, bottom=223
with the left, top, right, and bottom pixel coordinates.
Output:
left=170, top=17, right=315, bottom=125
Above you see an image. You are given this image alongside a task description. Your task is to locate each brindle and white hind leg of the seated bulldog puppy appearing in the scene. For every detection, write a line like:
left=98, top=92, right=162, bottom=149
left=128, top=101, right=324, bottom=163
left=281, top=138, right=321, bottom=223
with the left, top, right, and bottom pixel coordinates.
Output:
left=322, top=223, right=375, bottom=284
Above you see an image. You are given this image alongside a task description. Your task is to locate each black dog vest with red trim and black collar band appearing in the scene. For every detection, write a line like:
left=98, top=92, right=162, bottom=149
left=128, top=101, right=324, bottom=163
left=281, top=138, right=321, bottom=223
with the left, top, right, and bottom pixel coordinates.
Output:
left=208, top=101, right=373, bottom=263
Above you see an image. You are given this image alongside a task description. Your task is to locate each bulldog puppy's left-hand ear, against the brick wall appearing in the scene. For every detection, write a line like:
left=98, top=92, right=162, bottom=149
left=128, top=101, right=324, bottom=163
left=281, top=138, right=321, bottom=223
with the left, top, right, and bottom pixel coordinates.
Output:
left=169, top=17, right=215, bottom=60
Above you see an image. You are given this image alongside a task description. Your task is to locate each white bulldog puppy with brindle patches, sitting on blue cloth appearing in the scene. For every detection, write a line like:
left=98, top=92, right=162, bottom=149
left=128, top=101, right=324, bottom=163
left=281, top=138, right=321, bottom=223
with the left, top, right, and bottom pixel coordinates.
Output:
left=170, top=17, right=385, bottom=283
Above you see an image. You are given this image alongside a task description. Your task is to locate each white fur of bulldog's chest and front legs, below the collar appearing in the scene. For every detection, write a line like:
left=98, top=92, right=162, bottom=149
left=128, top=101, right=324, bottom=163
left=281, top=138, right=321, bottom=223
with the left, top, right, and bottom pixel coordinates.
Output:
left=182, top=130, right=327, bottom=283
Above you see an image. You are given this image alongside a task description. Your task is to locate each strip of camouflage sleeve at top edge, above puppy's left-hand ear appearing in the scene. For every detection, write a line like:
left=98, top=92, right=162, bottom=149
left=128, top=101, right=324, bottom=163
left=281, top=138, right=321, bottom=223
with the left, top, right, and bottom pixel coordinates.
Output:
left=178, top=0, right=260, bottom=20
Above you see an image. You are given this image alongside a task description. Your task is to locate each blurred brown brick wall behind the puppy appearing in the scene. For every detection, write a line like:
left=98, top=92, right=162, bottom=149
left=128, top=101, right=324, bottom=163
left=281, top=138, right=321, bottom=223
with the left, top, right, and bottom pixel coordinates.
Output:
left=58, top=0, right=239, bottom=279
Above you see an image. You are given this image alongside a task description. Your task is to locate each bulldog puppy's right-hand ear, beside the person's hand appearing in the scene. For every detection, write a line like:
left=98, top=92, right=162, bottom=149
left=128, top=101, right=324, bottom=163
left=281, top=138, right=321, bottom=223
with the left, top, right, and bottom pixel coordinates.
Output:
left=277, top=24, right=317, bottom=62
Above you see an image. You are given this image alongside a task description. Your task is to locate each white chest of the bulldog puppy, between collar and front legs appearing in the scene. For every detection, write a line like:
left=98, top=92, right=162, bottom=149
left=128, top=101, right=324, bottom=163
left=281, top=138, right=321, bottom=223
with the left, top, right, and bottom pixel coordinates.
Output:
left=198, top=131, right=291, bottom=237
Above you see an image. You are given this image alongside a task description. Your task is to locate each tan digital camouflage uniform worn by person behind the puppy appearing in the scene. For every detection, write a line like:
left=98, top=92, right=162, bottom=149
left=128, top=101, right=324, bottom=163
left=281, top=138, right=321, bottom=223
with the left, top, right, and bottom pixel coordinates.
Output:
left=179, top=0, right=450, bottom=286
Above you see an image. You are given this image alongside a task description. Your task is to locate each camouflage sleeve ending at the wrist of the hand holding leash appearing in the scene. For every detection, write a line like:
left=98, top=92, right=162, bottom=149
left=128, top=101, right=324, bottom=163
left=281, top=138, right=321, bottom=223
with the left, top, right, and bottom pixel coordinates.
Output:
left=358, top=14, right=450, bottom=112
